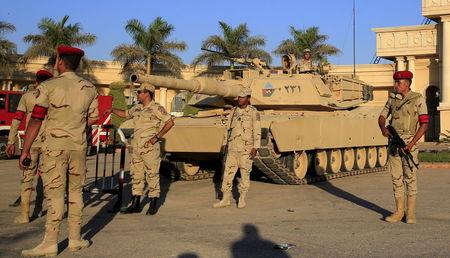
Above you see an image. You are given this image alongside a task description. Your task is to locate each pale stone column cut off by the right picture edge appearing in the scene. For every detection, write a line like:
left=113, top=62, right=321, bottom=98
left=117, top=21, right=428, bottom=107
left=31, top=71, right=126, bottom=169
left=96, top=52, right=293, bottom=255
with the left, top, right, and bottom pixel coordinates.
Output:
left=438, top=15, right=450, bottom=137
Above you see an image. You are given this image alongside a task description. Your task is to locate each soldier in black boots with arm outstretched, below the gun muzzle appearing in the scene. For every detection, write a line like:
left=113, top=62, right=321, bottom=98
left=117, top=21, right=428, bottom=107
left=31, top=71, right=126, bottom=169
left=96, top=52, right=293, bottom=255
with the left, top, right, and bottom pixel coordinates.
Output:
left=107, top=84, right=174, bottom=215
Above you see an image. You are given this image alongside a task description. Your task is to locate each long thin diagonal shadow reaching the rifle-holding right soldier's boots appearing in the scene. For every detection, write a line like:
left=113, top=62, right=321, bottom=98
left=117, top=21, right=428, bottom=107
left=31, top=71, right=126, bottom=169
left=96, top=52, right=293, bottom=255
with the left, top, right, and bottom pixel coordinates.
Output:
left=313, top=181, right=391, bottom=218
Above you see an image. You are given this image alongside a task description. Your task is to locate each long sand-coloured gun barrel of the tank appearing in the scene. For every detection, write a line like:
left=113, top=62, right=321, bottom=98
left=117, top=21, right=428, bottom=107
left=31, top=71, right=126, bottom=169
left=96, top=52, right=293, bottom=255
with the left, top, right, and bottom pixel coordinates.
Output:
left=130, top=74, right=245, bottom=97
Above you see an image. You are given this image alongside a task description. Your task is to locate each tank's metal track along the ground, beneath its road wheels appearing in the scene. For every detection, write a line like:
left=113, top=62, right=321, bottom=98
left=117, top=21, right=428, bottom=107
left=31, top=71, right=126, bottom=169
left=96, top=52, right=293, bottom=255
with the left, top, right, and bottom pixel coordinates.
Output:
left=253, top=145, right=387, bottom=185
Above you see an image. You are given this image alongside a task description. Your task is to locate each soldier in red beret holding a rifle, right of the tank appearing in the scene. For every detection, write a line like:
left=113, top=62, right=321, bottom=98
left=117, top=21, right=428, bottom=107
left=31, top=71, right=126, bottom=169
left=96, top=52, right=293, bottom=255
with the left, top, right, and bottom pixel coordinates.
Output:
left=378, top=71, right=428, bottom=224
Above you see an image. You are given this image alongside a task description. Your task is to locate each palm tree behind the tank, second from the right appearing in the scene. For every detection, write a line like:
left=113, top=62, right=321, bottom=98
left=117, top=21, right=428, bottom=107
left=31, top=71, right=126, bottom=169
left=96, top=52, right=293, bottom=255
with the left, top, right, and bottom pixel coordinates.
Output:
left=192, top=21, right=272, bottom=68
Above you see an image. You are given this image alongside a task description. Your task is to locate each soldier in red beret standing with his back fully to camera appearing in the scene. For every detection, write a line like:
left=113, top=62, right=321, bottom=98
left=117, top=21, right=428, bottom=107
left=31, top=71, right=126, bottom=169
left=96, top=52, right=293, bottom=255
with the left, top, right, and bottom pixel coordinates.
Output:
left=19, top=45, right=98, bottom=257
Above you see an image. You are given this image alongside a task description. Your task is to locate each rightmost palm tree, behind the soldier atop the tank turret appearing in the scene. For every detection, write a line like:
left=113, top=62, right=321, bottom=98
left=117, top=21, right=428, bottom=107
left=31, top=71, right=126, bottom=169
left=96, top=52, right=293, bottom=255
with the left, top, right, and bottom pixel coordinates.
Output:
left=274, top=26, right=341, bottom=63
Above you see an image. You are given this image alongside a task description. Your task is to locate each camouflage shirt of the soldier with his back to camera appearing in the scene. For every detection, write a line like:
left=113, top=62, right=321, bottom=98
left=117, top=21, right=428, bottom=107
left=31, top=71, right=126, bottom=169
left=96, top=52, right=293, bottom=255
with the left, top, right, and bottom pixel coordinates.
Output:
left=35, top=72, right=98, bottom=150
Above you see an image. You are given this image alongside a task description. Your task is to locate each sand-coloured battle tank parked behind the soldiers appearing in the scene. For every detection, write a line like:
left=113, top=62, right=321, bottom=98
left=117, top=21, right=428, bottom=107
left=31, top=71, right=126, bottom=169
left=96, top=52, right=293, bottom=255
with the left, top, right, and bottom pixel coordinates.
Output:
left=131, top=55, right=387, bottom=184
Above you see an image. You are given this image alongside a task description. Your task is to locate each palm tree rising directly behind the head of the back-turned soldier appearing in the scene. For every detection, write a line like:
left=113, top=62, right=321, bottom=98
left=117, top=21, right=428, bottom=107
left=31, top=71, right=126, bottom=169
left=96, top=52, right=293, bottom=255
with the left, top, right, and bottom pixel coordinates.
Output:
left=22, top=15, right=97, bottom=66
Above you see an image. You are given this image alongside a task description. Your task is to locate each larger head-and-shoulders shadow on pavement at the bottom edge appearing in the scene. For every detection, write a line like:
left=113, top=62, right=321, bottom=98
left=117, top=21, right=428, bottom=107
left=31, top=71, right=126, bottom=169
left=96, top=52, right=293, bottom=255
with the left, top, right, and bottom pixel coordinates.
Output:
left=231, top=224, right=290, bottom=258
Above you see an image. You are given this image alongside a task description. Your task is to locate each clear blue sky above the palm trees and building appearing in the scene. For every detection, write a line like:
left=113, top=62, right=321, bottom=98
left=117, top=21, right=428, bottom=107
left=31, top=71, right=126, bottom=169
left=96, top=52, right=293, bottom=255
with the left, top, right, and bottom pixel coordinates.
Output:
left=0, top=0, right=423, bottom=64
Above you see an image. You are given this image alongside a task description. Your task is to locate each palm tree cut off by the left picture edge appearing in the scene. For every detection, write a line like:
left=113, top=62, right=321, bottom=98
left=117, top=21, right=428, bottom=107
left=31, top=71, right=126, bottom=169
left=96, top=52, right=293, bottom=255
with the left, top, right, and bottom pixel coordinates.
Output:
left=0, top=21, right=17, bottom=74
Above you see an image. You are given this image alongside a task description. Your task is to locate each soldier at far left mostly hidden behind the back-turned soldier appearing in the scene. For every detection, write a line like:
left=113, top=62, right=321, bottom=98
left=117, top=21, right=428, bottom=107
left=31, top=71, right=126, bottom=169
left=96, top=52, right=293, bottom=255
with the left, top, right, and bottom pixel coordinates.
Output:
left=6, top=70, right=53, bottom=224
